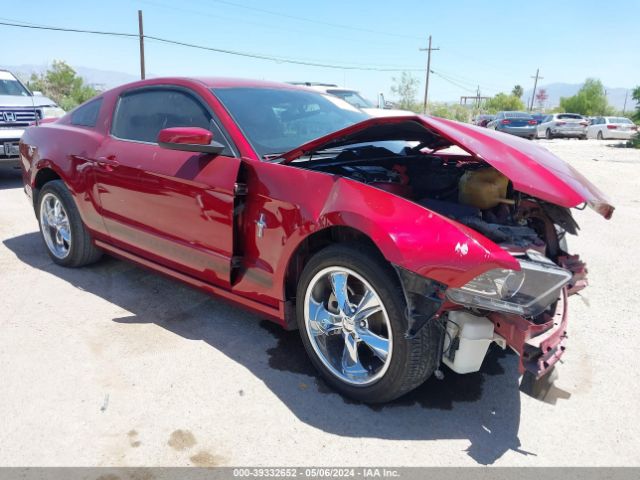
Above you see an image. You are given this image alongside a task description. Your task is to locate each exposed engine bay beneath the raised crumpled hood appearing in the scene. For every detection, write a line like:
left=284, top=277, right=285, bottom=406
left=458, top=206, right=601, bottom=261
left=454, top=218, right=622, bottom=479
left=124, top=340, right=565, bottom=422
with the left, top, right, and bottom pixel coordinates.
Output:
left=308, top=147, right=578, bottom=261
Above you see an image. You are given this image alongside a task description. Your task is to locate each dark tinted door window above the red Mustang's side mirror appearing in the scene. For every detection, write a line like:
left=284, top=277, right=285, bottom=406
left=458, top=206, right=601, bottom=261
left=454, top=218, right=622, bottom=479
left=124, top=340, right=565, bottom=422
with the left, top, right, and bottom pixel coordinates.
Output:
left=111, top=89, right=214, bottom=143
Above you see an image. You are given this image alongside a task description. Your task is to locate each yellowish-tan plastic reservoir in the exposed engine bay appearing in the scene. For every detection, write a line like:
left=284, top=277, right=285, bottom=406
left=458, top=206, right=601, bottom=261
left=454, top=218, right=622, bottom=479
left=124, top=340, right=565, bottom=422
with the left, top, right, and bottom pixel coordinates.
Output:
left=458, top=167, right=514, bottom=210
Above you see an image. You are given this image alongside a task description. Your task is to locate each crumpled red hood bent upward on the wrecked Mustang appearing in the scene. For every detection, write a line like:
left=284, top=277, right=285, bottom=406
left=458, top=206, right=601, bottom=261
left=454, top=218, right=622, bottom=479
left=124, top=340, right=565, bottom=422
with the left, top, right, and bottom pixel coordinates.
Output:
left=282, top=115, right=614, bottom=219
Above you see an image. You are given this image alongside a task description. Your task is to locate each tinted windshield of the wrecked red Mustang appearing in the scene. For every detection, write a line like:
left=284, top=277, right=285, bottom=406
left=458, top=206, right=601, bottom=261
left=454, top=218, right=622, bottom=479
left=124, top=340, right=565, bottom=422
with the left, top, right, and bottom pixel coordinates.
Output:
left=212, top=87, right=369, bottom=157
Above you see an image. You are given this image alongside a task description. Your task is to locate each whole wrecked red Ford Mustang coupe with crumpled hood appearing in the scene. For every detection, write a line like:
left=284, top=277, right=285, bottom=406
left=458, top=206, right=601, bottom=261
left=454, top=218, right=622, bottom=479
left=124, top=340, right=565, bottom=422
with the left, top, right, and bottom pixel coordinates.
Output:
left=20, top=78, right=613, bottom=402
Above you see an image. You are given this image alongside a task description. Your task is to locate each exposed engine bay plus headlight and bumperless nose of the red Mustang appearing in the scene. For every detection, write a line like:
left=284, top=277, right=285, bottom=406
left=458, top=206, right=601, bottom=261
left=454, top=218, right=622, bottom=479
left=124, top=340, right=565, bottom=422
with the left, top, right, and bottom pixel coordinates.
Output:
left=304, top=146, right=587, bottom=379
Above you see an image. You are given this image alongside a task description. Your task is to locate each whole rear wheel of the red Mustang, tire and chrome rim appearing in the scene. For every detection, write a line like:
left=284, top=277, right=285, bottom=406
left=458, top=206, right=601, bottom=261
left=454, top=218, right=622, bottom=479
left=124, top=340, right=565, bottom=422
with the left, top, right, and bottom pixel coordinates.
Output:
left=36, top=180, right=102, bottom=267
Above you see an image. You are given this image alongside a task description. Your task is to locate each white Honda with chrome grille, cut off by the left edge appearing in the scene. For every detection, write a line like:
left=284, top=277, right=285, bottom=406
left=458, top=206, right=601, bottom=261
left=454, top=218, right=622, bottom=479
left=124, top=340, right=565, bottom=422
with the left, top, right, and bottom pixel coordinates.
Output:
left=0, top=70, right=65, bottom=166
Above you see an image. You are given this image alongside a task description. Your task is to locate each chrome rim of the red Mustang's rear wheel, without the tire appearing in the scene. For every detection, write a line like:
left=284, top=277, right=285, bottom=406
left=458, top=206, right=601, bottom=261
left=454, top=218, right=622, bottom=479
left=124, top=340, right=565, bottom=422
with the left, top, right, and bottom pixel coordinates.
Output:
left=40, top=193, right=71, bottom=259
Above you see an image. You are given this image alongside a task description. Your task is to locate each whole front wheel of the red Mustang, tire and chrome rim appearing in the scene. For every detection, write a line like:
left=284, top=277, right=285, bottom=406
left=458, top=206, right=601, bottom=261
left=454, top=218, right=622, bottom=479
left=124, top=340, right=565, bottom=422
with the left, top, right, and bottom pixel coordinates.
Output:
left=296, top=244, right=442, bottom=403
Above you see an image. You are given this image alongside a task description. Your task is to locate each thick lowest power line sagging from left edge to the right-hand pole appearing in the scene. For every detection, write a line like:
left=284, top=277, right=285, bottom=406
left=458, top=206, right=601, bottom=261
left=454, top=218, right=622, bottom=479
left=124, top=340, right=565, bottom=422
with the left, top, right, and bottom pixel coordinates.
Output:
left=0, top=22, right=424, bottom=72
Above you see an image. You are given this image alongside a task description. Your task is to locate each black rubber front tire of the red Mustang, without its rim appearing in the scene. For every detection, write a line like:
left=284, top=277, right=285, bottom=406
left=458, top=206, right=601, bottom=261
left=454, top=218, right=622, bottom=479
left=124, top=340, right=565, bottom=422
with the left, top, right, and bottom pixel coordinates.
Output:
left=296, top=244, right=442, bottom=403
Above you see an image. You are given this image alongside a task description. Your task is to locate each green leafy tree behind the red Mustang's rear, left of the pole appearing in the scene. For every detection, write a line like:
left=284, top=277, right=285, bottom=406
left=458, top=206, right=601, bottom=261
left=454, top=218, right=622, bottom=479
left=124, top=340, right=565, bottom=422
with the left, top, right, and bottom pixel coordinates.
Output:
left=27, top=60, right=99, bottom=111
